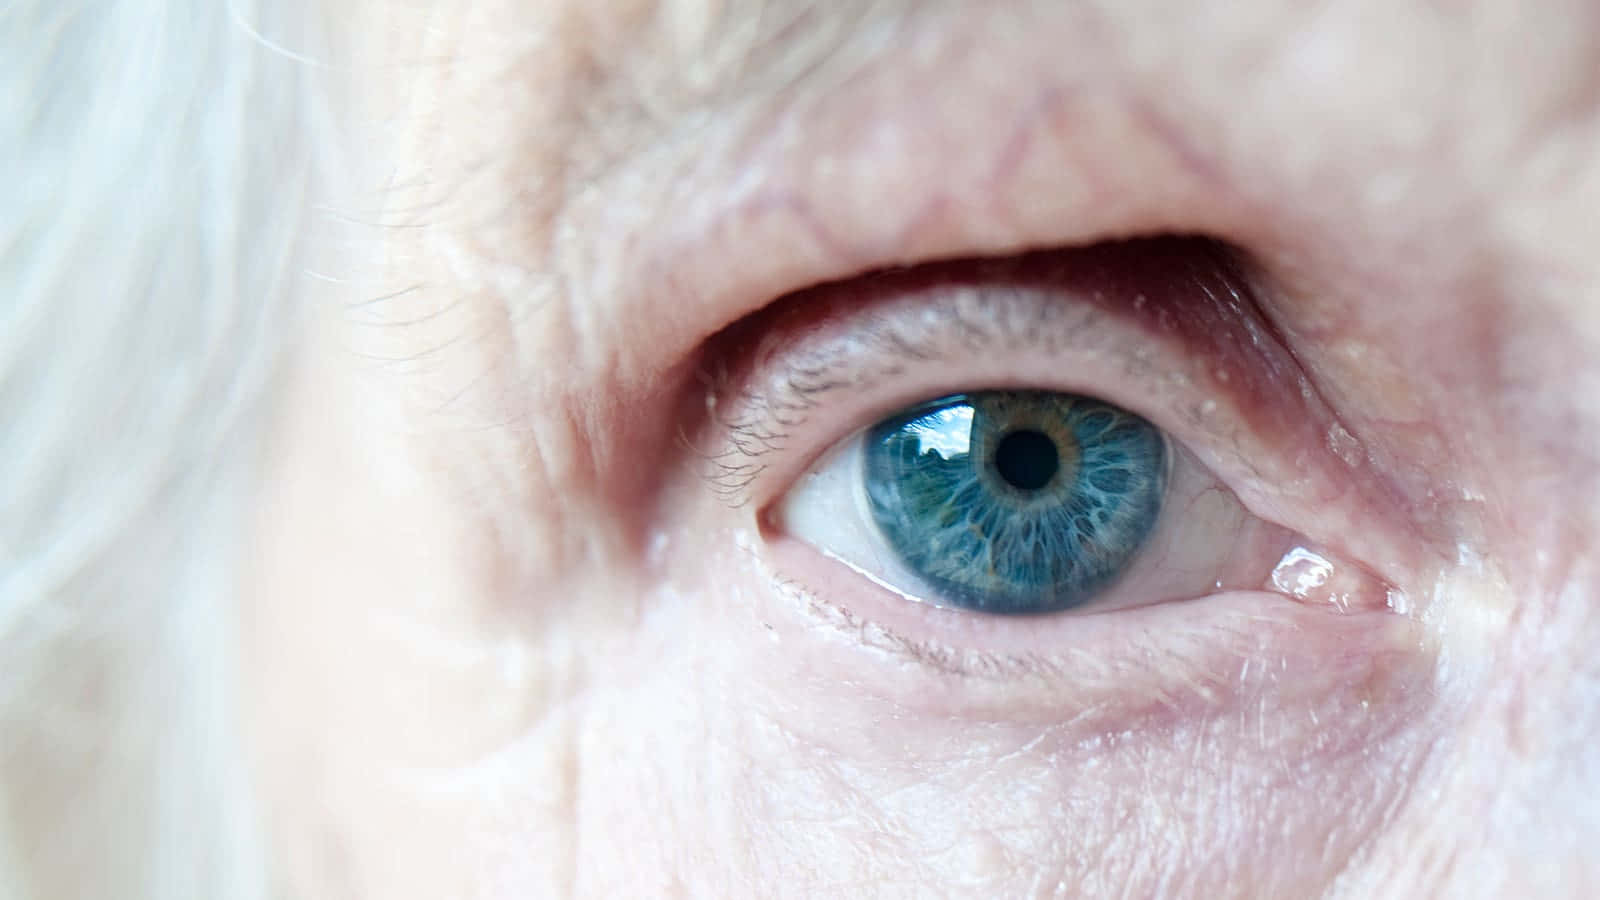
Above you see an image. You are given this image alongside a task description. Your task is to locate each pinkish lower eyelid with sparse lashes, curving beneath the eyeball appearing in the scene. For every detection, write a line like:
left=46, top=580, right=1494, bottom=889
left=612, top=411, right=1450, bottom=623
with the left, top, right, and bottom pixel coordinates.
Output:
left=742, top=535, right=1432, bottom=727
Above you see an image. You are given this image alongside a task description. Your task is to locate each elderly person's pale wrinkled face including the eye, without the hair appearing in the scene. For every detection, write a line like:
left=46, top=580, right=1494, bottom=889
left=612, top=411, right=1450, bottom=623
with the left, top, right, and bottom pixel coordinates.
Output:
left=245, top=0, right=1600, bottom=900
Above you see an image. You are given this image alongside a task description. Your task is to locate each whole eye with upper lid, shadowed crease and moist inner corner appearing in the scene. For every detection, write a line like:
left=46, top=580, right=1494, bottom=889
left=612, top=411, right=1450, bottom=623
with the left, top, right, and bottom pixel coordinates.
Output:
left=700, top=240, right=1405, bottom=666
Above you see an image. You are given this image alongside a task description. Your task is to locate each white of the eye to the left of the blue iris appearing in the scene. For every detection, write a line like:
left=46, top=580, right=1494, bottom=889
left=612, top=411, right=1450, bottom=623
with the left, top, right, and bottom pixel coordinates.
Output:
left=776, top=434, right=934, bottom=602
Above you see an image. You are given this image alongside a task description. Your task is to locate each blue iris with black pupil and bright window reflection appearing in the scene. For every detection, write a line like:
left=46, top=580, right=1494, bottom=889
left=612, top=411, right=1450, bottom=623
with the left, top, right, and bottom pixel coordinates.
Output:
left=864, top=391, right=1166, bottom=613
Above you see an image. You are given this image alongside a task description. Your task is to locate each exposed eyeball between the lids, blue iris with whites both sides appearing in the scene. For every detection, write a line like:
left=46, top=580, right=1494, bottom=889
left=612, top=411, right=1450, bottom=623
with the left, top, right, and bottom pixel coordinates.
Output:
left=774, top=389, right=1259, bottom=615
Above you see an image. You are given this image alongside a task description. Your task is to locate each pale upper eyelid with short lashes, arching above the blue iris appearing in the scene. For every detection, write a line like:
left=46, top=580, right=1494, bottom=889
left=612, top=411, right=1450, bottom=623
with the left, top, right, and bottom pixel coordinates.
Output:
left=710, top=241, right=1248, bottom=500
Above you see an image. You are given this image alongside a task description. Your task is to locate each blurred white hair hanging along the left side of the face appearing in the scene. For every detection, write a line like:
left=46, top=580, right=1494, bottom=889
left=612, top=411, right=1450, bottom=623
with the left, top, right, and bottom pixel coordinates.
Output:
left=0, top=0, right=328, bottom=900
